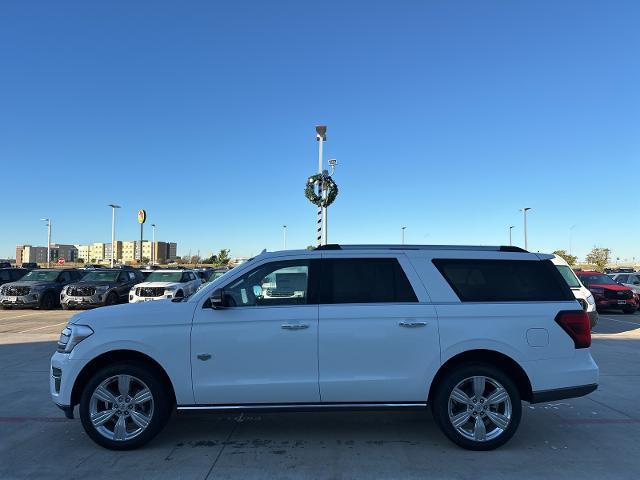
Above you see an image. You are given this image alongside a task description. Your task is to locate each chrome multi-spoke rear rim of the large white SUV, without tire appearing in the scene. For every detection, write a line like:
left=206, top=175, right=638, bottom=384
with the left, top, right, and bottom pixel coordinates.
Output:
left=448, top=376, right=512, bottom=442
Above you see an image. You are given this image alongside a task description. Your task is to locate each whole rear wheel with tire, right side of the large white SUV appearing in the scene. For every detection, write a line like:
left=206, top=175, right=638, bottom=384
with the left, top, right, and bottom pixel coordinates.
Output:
left=431, top=364, right=522, bottom=450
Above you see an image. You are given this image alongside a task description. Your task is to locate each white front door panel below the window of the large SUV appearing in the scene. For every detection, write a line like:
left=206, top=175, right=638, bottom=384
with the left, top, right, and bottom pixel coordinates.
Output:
left=191, top=305, right=320, bottom=404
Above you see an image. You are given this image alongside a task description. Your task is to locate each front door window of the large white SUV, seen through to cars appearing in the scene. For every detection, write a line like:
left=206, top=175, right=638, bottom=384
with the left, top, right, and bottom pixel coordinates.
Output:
left=224, top=260, right=310, bottom=307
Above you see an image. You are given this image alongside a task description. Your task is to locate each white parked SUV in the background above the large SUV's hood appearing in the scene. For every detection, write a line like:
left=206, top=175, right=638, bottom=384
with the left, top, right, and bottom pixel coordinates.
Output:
left=129, top=270, right=202, bottom=303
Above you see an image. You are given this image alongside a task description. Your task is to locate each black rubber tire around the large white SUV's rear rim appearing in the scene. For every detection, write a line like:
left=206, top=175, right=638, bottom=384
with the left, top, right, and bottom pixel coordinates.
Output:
left=431, top=363, right=522, bottom=450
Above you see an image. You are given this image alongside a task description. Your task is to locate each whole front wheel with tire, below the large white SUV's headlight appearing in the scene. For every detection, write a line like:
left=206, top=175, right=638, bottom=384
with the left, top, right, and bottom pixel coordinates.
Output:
left=80, top=362, right=172, bottom=450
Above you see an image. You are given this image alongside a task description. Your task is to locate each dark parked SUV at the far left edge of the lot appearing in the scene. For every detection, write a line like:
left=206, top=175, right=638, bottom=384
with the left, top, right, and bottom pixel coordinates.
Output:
left=0, top=268, right=82, bottom=310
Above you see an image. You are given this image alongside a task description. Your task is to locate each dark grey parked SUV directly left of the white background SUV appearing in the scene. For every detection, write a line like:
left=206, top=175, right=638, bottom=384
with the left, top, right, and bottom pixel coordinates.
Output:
left=60, top=268, right=144, bottom=310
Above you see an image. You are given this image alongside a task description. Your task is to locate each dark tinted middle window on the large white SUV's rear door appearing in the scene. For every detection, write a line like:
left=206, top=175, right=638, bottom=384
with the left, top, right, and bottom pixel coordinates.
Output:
left=320, top=258, right=418, bottom=304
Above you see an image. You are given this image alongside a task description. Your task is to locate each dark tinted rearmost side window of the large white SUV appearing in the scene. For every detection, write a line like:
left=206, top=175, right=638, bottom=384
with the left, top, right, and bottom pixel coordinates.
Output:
left=433, top=259, right=574, bottom=302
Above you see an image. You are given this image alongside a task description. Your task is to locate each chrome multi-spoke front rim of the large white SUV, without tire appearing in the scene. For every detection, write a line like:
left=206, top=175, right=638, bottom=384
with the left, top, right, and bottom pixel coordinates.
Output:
left=89, top=374, right=154, bottom=441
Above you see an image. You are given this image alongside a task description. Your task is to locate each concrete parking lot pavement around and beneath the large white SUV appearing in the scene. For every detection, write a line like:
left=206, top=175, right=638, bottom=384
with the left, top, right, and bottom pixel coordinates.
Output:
left=0, top=310, right=640, bottom=479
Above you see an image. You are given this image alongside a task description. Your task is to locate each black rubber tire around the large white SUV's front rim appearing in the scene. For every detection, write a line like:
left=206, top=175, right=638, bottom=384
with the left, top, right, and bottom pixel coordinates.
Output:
left=79, top=362, right=173, bottom=450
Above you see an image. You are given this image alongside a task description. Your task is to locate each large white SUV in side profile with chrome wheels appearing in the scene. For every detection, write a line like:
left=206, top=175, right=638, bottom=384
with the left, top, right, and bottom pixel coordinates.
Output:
left=50, top=245, right=598, bottom=450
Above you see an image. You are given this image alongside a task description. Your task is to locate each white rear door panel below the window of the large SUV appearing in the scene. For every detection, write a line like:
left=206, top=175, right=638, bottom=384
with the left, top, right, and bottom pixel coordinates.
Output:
left=318, top=303, right=440, bottom=402
